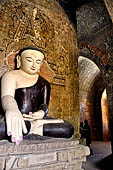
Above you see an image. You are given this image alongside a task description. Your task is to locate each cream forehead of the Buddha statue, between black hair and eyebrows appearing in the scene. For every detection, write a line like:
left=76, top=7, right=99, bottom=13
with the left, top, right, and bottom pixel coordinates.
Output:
left=21, top=49, right=44, bottom=59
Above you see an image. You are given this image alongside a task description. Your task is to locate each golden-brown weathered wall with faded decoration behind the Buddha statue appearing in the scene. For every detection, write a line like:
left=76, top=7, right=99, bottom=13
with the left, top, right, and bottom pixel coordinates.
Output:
left=0, top=0, right=79, bottom=135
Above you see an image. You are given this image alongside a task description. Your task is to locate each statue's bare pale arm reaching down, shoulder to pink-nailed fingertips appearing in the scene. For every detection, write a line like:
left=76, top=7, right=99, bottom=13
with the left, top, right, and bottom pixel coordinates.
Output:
left=1, top=72, right=27, bottom=144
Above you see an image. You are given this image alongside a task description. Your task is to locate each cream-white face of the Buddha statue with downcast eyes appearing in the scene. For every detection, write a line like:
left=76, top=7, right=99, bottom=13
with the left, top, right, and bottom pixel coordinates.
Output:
left=20, top=50, right=44, bottom=75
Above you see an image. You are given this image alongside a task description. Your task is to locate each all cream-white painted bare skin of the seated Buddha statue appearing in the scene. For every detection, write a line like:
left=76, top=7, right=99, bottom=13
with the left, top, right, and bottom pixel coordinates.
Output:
left=1, top=49, right=63, bottom=145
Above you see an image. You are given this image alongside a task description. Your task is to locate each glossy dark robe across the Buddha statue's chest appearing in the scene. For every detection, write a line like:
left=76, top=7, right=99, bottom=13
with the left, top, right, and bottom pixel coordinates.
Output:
left=15, top=76, right=51, bottom=115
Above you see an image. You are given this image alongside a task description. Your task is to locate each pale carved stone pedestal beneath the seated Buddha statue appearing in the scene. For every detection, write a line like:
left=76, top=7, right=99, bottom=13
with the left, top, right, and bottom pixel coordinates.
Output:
left=0, top=139, right=89, bottom=170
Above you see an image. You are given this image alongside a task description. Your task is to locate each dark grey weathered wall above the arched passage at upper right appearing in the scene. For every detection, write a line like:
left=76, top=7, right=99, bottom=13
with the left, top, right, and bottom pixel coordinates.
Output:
left=76, top=1, right=112, bottom=48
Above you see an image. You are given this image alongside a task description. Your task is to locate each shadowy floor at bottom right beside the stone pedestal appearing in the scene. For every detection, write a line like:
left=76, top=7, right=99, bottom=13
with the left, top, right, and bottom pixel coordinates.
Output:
left=83, top=141, right=113, bottom=170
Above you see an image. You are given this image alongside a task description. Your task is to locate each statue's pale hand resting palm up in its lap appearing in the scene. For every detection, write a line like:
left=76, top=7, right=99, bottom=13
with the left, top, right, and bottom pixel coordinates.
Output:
left=23, top=110, right=44, bottom=121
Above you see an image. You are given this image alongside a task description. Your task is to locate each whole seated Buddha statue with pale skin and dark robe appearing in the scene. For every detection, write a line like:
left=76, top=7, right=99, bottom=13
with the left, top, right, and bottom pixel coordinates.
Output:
left=0, top=47, right=74, bottom=145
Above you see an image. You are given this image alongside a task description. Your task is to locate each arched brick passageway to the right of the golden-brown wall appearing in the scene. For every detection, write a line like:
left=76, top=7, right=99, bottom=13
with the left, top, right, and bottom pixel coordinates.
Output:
left=78, top=56, right=109, bottom=140
